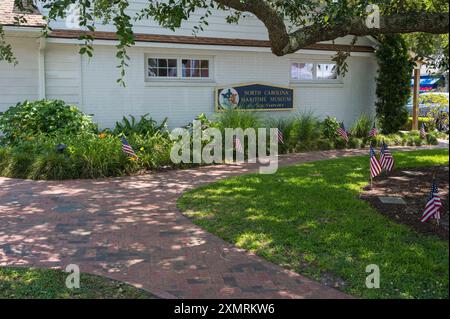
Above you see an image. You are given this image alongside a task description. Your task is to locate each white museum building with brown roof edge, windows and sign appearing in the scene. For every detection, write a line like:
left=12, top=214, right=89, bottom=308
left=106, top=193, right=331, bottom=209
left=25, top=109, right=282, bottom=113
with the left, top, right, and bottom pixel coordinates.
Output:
left=0, top=0, right=377, bottom=128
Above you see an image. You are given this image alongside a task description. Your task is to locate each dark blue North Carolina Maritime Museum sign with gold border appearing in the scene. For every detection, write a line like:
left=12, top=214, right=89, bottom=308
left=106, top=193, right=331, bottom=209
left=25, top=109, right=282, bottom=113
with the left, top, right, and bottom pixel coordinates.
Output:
left=216, top=83, right=294, bottom=112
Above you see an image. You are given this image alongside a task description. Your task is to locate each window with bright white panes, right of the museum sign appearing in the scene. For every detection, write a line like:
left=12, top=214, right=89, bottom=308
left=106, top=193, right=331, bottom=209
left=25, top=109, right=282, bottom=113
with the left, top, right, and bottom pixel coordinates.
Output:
left=291, top=62, right=339, bottom=82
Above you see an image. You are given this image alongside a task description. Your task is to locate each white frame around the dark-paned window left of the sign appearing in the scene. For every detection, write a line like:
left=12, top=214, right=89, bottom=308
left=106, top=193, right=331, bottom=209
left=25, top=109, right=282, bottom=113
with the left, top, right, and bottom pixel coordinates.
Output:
left=144, top=54, right=214, bottom=82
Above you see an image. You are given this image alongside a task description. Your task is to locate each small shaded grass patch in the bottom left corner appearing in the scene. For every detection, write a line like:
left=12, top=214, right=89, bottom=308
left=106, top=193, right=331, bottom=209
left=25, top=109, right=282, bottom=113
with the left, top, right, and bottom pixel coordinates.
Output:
left=0, top=267, right=155, bottom=299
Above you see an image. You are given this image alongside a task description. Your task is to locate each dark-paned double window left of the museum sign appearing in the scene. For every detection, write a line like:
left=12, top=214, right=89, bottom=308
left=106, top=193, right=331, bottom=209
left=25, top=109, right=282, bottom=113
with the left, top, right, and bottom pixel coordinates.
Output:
left=146, top=57, right=212, bottom=80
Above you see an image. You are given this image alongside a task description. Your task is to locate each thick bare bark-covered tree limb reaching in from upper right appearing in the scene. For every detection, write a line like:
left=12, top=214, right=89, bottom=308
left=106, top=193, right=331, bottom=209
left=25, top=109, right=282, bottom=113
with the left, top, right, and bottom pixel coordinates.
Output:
left=214, top=0, right=449, bottom=56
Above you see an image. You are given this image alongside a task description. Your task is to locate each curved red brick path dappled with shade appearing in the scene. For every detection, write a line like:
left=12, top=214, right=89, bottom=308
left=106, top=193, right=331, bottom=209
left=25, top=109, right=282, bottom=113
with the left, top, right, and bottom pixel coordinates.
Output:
left=0, top=146, right=442, bottom=298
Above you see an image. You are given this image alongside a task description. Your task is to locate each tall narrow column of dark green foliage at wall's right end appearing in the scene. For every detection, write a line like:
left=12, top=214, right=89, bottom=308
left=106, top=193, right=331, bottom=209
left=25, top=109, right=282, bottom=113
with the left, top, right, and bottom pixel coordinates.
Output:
left=376, top=35, right=413, bottom=134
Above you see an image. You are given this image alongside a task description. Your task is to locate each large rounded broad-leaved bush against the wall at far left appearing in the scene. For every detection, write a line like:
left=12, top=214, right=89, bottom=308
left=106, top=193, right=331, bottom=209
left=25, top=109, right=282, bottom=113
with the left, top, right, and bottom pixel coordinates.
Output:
left=0, top=100, right=97, bottom=143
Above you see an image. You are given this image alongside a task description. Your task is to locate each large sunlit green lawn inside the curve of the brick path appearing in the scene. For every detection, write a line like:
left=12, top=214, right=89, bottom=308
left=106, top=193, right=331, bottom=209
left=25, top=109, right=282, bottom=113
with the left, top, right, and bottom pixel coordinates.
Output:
left=178, top=150, right=449, bottom=298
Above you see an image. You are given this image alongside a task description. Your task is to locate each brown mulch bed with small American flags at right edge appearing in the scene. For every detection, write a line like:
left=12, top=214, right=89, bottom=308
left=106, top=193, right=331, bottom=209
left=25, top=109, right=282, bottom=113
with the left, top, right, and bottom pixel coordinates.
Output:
left=361, top=167, right=449, bottom=240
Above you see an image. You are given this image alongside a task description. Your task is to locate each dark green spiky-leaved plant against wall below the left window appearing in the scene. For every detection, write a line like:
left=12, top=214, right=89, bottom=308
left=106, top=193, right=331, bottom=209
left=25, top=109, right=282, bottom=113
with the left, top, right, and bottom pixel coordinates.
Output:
left=114, top=114, right=167, bottom=136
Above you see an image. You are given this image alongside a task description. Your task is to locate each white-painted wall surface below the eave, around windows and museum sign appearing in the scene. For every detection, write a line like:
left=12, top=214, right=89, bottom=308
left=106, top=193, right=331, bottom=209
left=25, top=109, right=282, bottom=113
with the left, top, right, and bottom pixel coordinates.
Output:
left=46, top=45, right=376, bottom=127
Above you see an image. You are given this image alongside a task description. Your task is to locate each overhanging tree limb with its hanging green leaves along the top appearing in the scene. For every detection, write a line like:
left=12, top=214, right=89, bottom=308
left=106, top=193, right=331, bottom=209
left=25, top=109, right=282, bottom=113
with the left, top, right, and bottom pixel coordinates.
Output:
left=1, top=0, right=449, bottom=81
